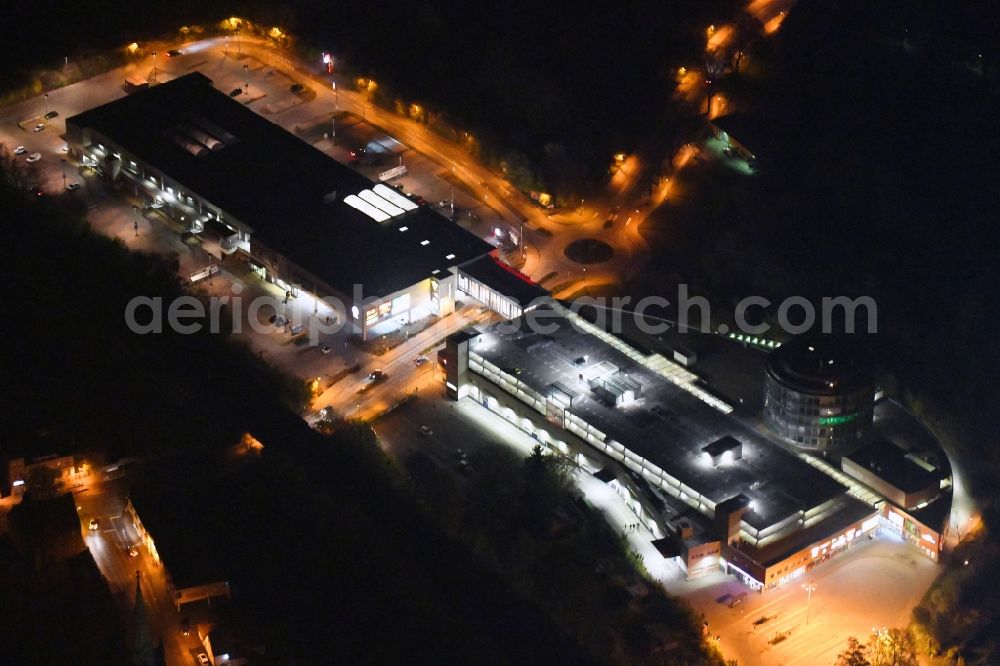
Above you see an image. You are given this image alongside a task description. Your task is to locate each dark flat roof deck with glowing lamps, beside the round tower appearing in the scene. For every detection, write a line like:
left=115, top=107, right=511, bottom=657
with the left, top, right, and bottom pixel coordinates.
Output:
left=472, top=317, right=845, bottom=529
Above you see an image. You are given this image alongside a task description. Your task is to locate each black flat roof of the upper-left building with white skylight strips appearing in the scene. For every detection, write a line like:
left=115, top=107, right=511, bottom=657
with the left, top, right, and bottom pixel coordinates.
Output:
left=66, top=72, right=491, bottom=296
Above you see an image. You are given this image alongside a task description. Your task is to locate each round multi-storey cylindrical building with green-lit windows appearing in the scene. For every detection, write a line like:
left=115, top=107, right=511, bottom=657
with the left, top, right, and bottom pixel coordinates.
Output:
left=764, top=336, right=875, bottom=454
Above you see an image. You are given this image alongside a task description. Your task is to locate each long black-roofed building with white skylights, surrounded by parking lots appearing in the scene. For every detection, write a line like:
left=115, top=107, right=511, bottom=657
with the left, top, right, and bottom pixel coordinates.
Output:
left=66, top=72, right=496, bottom=335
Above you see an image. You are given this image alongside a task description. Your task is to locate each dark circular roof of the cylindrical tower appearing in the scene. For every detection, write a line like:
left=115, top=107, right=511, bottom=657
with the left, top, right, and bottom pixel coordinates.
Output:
left=767, top=335, right=873, bottom=395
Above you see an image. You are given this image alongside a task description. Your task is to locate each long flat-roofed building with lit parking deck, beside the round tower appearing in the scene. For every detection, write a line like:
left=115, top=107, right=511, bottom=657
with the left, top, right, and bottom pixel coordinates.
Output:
left=448, top=304, right=880, bottom=589
